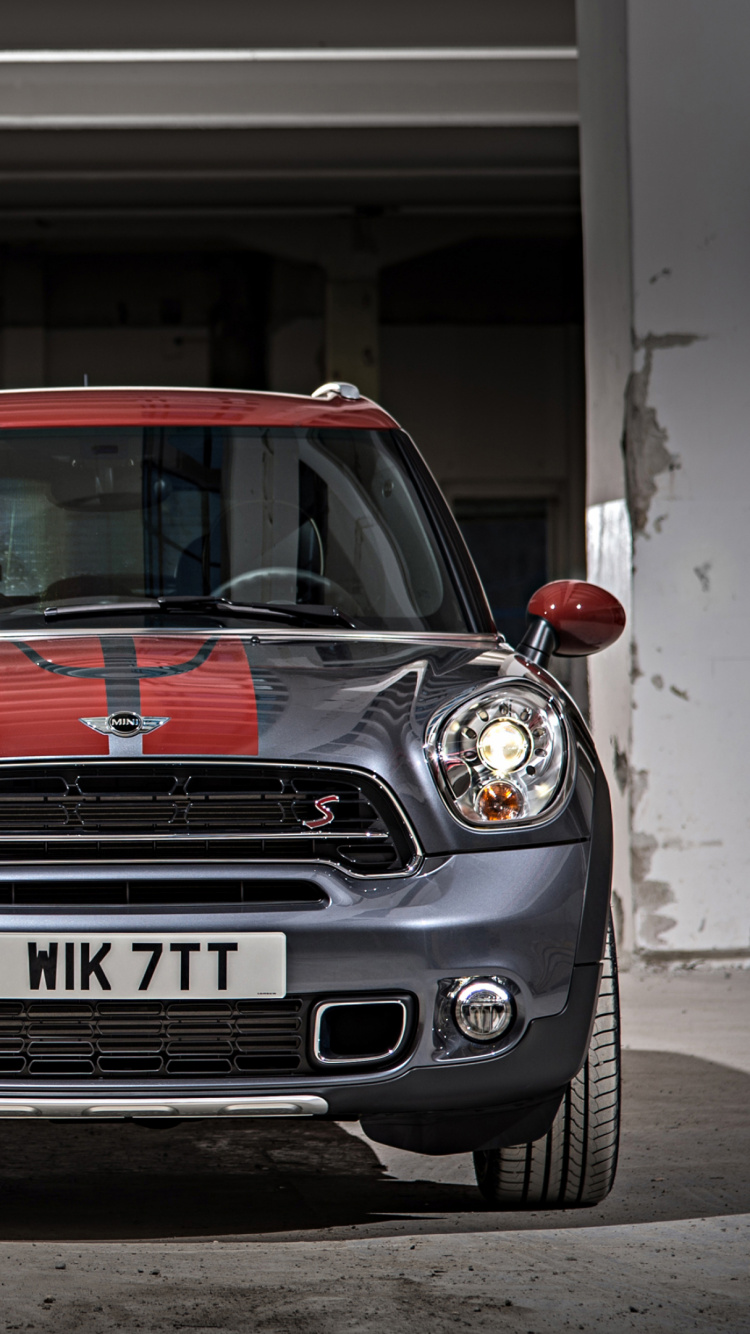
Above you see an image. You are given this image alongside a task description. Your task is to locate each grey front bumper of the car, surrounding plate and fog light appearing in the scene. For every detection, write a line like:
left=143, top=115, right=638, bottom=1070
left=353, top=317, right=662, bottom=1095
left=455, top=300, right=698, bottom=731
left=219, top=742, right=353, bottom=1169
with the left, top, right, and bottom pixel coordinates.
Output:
left=0, top=842, right=597, bottom=1119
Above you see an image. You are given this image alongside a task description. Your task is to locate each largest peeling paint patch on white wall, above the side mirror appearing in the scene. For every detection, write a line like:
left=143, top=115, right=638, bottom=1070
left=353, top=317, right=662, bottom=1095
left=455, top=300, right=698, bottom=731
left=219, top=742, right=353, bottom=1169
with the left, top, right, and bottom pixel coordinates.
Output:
left=623, top=334, right=702, bottom=534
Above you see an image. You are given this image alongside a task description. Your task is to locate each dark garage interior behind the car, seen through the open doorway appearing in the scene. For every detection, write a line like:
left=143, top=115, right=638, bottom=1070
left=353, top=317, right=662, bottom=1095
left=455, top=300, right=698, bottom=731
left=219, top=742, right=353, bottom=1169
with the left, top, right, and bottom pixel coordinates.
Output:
left=0, top=0, right=586, bottom=677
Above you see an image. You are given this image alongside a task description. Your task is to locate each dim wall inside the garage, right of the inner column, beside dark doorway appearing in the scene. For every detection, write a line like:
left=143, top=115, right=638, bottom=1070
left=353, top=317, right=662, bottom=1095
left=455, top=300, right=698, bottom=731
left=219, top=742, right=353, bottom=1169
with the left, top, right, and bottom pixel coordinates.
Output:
left=380, top=324, right=585, bottom=576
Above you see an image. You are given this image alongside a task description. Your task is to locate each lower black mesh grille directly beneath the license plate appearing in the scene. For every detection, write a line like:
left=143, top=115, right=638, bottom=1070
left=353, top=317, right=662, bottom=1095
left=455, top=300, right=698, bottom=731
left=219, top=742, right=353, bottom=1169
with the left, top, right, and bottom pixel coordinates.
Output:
left=0, top=996, right=307, bottom=1082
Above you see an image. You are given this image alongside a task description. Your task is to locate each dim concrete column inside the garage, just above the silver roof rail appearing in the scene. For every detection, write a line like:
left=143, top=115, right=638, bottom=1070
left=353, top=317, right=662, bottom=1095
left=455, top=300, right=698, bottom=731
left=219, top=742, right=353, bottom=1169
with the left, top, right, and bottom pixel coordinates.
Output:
left=326, top=276, right=380, bottom=399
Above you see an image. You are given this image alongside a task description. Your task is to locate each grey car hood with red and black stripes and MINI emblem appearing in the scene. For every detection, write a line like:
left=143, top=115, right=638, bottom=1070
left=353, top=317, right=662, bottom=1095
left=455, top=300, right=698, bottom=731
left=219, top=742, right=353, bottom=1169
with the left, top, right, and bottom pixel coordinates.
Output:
left=0, top=631, right=586, bottom=843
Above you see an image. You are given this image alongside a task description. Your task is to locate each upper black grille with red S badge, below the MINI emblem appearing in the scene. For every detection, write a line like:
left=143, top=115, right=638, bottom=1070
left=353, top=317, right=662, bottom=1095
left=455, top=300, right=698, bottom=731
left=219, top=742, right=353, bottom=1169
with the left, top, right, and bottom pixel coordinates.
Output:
left=0, top=759, right=416, bottom=875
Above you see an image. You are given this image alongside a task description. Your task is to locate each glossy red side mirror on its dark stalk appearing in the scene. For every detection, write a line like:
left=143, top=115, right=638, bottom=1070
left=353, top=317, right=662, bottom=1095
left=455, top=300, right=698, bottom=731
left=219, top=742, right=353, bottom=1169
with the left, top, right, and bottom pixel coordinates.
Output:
left=516, top=579, right=625, bottom=667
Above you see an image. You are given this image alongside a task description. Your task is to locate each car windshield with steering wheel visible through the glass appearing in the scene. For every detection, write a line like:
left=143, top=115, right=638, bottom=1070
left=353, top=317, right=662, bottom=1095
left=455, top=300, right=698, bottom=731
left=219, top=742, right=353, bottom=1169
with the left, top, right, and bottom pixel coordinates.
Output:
left=0, top=427, right=467, bottom=631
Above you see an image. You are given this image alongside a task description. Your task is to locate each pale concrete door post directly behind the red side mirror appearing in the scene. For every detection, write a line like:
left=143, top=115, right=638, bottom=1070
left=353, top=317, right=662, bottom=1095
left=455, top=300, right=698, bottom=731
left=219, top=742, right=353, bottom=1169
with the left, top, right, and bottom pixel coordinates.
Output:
left=577, top=0, right=634, bottom=962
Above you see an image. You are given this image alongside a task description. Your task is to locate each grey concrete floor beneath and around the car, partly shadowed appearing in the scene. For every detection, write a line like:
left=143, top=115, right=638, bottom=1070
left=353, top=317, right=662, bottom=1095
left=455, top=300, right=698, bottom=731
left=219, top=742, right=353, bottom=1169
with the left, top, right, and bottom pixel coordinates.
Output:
left=0, top=968, right=750, bottom=1334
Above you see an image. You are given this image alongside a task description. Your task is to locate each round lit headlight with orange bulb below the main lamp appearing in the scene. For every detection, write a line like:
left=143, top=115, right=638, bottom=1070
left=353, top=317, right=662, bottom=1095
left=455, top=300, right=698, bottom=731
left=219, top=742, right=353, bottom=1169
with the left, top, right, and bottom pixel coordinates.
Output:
left=427, top=680, right=567, bottom=827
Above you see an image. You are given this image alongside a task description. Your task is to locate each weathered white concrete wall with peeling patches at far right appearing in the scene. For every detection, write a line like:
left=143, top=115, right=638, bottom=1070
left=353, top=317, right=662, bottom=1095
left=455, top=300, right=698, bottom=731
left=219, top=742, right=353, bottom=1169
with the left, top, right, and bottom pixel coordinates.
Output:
left=579, top=0, right=750, bottom=958
